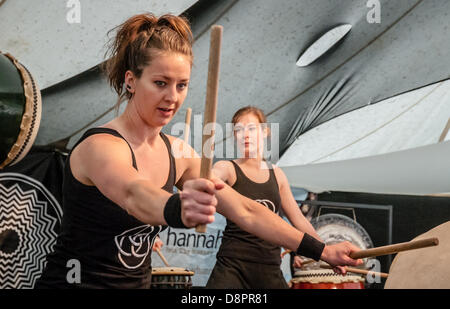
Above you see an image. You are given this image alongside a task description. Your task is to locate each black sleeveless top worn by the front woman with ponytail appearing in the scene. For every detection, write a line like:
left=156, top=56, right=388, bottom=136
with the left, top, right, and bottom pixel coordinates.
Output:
left=35, top=128, right=176, bottom=288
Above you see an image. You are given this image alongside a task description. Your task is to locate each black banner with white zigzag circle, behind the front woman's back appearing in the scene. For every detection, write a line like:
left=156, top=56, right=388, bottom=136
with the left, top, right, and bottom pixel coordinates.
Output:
left=0, top=149, right=65, bottom=289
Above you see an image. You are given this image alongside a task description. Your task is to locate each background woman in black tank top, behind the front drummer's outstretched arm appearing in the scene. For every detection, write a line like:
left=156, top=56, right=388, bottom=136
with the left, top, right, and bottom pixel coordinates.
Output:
left=207, top=107, right=326, bottom=289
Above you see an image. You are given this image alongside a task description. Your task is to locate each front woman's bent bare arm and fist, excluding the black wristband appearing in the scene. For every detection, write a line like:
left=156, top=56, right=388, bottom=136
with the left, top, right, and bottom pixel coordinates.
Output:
left=70, top=134, right=217, bottom=226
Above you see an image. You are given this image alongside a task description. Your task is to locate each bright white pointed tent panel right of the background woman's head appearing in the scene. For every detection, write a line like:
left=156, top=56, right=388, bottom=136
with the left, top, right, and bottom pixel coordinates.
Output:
left=278, top=80, right=450, bottom=166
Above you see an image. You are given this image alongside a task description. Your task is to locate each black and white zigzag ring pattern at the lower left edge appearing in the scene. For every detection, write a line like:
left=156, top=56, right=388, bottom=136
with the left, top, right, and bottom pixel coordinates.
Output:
left=0, top=177, right=59, bottom=288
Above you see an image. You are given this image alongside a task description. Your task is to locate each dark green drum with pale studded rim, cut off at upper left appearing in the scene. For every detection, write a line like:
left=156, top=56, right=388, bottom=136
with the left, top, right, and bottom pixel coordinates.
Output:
left=0, top=52, right=42, bottom=169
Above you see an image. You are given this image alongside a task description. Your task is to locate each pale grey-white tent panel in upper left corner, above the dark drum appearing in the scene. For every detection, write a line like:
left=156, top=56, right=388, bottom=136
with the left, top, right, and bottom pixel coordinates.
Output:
left=0, top=0, right=196, bottom=89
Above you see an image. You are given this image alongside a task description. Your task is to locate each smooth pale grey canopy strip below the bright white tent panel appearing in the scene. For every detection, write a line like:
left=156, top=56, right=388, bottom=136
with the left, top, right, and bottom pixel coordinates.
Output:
left=280, top=141, right=450, bottom=195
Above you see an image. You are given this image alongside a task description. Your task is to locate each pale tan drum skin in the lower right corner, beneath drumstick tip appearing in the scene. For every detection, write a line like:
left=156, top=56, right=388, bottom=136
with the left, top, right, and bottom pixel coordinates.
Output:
left=384, top=221, right=450, bottom=289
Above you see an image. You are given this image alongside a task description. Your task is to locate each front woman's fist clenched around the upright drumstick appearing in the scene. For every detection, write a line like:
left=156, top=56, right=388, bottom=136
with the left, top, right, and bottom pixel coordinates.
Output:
left=180, top=178, right=224, bottom=227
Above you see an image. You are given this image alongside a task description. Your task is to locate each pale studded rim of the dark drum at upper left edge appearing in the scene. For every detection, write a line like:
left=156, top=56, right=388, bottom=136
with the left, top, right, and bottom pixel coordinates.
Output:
left=0, top=51, right=42, bottom=169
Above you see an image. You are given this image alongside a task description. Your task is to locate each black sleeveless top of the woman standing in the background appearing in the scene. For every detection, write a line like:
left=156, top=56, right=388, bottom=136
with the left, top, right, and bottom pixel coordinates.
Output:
left=217, top=161, right=281, bottom=265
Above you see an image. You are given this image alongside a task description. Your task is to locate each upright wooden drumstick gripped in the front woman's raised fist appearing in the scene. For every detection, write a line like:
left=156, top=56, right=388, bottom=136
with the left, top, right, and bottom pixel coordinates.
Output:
left=195, top=25, right=223, bottom=233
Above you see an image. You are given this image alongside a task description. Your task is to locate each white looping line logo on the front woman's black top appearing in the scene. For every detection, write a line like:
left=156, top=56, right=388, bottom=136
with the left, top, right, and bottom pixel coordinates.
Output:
left=114, top=224, right=162, bottom=269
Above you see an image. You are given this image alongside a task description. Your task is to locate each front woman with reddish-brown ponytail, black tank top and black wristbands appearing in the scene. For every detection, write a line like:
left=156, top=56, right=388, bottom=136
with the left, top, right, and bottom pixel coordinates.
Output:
left=35, top=14, right=357, bottom=288
